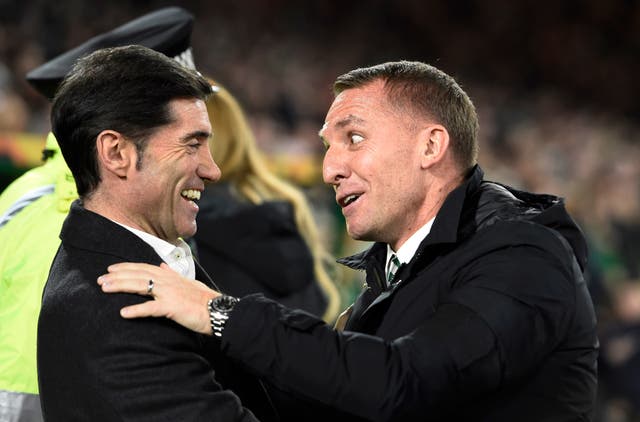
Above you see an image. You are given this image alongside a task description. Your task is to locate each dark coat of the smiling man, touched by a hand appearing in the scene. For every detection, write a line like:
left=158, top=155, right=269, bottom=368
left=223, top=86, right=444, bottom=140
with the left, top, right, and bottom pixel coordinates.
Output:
left=38, top=201, right=268, bottom=422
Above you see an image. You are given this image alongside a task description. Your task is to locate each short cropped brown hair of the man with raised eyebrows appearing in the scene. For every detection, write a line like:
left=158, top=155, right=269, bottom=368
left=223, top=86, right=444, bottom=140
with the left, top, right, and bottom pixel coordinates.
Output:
left=333, top=61, right=479, bottom=171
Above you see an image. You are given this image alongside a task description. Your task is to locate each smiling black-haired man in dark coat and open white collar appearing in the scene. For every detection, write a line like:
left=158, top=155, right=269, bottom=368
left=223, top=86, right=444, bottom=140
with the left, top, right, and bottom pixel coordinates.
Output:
left=37, top=46, right=264, bottom=421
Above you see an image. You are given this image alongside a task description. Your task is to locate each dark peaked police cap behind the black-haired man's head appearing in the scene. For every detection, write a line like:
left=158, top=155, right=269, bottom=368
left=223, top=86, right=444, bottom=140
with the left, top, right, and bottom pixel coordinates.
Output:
left=27, top=7, right=195, bottom=99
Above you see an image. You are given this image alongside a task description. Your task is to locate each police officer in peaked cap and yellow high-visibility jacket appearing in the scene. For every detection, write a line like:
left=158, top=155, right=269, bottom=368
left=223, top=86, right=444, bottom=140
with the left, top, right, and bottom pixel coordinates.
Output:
left=0, top=7, right=194, bottom=422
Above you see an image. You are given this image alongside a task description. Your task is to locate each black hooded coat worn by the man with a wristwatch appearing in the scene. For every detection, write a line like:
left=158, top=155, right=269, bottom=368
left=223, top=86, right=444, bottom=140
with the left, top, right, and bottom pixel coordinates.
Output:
left=222, top=167, right=598, bottom=422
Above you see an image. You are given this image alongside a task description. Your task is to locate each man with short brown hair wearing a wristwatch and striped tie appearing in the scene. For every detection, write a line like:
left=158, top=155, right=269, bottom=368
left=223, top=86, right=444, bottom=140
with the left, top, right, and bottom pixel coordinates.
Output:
left=98, top=61, right=598, bottom=422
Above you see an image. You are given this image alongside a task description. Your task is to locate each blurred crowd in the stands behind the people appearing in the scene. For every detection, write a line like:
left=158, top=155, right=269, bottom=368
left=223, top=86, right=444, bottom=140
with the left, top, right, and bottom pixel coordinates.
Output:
left=0, top=0, right=640, bottom=421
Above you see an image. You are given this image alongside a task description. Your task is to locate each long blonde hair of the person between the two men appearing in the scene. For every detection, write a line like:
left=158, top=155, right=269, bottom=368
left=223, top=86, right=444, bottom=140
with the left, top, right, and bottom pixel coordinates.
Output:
left=207, top=81, right=340, bottom=322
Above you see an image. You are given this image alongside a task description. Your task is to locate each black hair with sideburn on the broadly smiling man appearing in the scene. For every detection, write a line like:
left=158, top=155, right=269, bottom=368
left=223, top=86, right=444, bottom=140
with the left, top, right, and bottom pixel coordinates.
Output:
left=51, top=45, right=211, bottom=197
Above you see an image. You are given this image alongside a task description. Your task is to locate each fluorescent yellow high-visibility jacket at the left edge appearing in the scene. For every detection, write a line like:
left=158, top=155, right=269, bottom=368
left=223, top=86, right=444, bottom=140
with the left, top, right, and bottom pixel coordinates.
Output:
left=0, top=134, right=77, bottom=421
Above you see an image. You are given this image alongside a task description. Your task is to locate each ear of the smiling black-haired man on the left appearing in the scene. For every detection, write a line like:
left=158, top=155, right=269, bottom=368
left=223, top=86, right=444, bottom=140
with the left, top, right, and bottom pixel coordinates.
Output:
left=96, top=130, right=137, bottom=178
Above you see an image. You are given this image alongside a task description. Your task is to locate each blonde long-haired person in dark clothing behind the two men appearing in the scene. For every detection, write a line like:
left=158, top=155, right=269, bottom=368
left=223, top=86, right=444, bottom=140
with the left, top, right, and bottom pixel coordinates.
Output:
left=192, top=81, right=340, bottom=321
